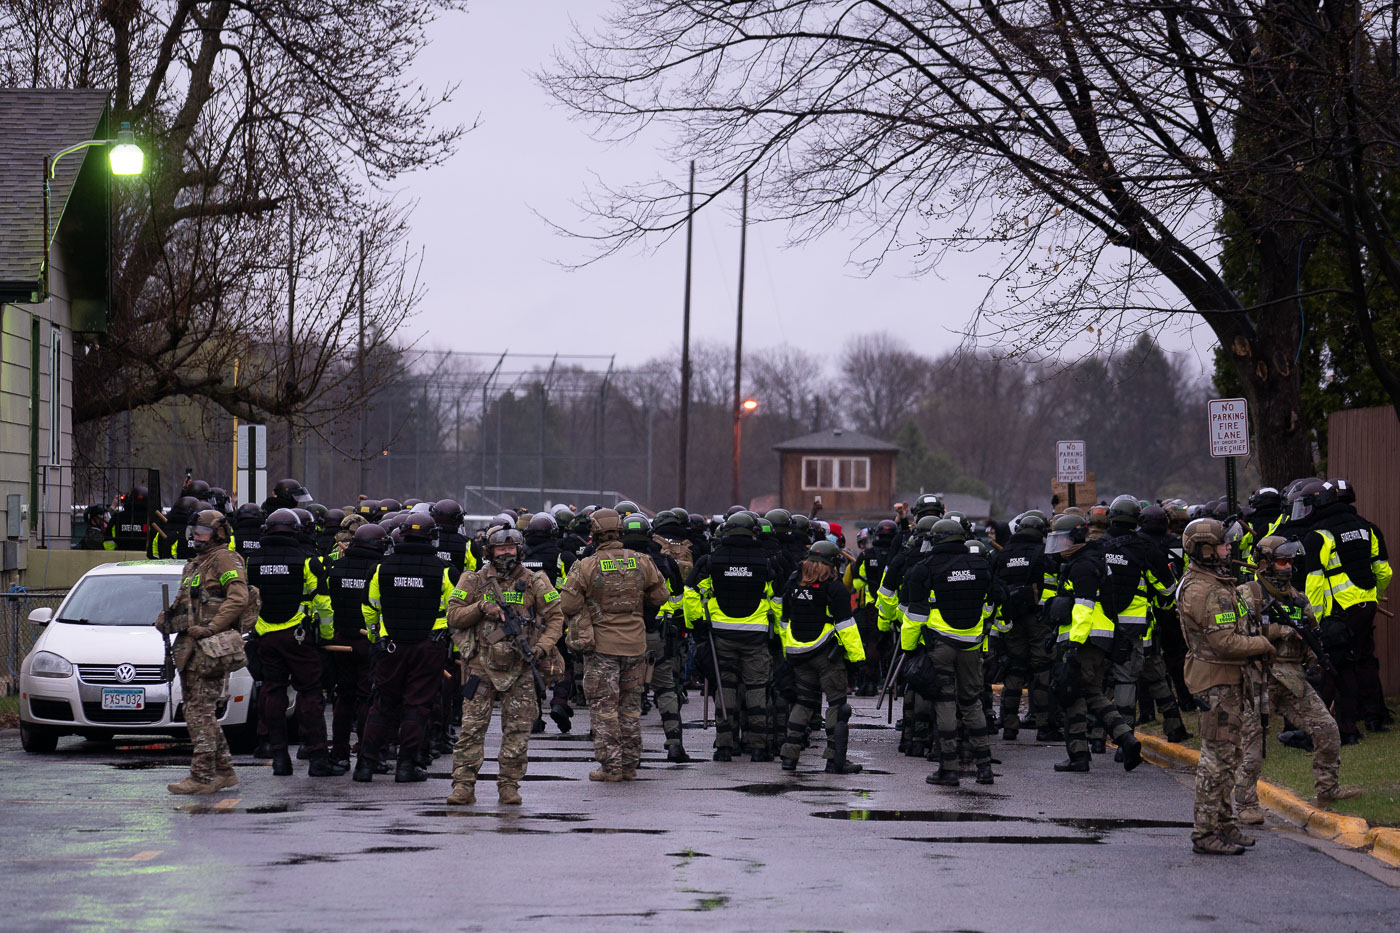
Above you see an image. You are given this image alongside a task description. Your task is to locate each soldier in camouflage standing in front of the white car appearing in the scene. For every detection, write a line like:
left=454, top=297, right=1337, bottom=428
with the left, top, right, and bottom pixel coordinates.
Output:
left=155, top=509, right=249, bottom=794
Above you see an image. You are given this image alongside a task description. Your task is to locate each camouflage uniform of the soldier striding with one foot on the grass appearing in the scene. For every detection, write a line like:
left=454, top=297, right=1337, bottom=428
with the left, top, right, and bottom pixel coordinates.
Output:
left=1235, top=580, right=1341, bottom=811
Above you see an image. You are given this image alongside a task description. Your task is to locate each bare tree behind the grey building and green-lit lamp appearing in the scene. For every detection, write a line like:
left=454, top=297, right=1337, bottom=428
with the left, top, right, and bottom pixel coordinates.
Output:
left=0, top=0, right=462, bottom=430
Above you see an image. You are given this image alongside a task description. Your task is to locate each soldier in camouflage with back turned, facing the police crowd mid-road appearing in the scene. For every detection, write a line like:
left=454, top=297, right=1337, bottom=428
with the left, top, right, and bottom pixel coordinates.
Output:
left=560, top=509, right=671, bottom=782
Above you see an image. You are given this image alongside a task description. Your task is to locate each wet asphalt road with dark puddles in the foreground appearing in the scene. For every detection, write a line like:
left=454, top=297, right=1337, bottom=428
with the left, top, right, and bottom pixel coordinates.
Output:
left=0, top=699, right=1400, bottom=930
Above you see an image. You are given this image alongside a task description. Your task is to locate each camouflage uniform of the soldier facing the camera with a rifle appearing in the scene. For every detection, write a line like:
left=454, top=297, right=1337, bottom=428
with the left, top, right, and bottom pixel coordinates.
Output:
left=447, top=554, right=564, bottom=796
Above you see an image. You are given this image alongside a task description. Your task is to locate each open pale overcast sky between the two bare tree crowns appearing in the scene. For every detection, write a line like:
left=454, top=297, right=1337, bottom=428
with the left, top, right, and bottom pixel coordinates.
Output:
left=402, top=0, right=1208, bottom=375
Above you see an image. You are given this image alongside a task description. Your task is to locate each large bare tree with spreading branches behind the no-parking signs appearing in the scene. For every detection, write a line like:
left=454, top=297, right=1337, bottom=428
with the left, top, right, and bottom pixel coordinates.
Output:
left=543, top=0, right=1400, bottom=482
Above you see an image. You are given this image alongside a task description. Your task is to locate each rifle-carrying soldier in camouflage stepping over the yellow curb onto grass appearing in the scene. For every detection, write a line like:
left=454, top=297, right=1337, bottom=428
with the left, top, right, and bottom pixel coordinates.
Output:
left=1235, top=535, right=1361, bottom=824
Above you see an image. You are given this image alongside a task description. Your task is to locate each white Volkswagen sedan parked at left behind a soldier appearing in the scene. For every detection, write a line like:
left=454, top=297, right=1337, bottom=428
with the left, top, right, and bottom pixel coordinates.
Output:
left=20, top=560, right=256, bottom=752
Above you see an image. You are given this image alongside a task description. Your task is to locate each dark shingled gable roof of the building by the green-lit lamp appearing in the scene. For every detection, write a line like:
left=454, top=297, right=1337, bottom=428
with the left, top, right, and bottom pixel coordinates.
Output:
left=0, top=88, right=111, bottom=297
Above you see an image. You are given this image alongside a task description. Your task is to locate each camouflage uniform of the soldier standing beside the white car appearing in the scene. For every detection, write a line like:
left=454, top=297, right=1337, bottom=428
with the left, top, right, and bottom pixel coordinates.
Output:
left=157, top=546, right=248, bottom=793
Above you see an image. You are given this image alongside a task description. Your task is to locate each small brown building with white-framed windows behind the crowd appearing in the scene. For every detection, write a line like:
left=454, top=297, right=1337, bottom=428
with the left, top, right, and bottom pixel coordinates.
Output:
left=773, top=427, right=899, bottom=521
